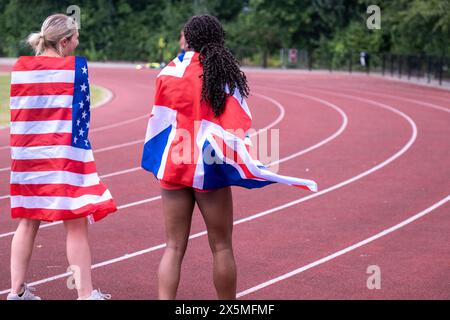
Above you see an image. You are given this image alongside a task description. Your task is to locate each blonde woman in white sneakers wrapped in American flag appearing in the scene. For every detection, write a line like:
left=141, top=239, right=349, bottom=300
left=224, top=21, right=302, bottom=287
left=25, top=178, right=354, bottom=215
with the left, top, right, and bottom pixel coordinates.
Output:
left=7, top=14, right=117, bottom=300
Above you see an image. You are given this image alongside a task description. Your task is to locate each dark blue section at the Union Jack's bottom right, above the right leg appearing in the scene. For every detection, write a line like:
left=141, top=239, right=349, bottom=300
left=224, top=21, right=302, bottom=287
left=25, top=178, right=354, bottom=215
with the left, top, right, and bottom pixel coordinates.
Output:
left=203, top=140, right=275, bottom=190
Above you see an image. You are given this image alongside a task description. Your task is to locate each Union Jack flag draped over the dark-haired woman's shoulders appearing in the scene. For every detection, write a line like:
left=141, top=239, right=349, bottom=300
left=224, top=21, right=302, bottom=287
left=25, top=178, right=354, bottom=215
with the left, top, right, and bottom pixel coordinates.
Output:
left=142, top=51, right=317, bottom=191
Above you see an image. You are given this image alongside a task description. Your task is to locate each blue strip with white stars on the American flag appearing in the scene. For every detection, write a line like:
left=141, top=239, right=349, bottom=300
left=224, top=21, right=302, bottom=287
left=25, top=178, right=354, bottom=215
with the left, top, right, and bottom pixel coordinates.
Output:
left=72, top=57, right=91, bottom=150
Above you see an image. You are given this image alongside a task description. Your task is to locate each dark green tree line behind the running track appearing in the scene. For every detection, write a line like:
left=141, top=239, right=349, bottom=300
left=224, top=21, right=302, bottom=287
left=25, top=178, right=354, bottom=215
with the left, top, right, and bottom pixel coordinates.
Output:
left=0, top=0, right=450, bottom=65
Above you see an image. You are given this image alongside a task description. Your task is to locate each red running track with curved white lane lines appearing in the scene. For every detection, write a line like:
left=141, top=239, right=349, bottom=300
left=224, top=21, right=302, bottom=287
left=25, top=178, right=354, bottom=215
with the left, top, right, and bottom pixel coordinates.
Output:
left=0, top=67, right=450, bottom=299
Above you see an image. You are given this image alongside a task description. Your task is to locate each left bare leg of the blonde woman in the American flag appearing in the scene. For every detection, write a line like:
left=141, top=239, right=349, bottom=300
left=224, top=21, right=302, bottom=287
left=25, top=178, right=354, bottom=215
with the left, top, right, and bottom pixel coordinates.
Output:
left=11, top=218, right=41, bottom=294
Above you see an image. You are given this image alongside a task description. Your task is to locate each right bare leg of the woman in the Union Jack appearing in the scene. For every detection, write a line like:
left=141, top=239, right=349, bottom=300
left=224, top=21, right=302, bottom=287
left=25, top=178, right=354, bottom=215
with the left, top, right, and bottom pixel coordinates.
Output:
left=195, top=187, right=237, bottom=300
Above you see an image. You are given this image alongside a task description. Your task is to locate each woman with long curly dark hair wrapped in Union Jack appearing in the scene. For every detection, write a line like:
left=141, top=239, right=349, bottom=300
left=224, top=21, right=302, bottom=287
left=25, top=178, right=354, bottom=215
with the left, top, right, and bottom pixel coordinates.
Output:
left=142, top=15, right=317, bottom=299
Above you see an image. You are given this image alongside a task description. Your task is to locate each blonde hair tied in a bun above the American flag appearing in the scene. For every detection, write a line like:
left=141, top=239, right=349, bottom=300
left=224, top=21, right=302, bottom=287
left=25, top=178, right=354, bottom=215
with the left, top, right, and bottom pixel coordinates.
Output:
left=27, top=14, right=78, bottom=56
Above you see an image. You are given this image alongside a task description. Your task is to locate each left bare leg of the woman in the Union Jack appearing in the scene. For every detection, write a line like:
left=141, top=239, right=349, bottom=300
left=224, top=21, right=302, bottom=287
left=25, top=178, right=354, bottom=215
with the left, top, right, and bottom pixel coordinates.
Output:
left=158, top=188, right=195, bottom=300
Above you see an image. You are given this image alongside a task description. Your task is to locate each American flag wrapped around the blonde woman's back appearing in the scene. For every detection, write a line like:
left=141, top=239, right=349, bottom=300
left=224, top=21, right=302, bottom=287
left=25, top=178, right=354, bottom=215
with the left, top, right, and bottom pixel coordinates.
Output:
left=10, top=56, right=117, bottom=222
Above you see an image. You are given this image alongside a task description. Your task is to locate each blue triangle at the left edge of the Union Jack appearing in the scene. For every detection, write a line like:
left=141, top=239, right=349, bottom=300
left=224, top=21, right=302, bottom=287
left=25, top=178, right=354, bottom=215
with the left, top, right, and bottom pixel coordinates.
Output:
left=141, top=126, right=172, bottom=177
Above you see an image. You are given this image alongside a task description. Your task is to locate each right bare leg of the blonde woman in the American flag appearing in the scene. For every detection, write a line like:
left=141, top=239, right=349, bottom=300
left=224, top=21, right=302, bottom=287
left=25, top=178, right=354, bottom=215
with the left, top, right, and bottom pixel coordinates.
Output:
left=64, top=218, right=93, bottom=299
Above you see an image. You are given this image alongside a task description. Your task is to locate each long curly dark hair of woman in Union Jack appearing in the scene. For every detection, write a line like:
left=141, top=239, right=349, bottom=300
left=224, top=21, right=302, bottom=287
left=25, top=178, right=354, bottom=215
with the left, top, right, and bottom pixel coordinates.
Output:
left=183, top=14, right=250, bottom=117
